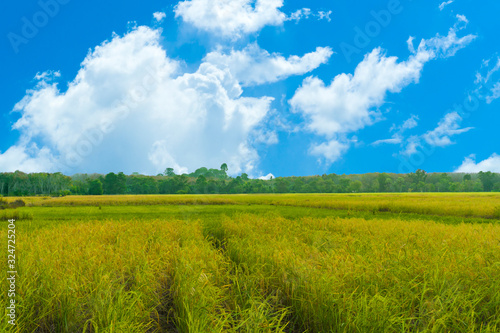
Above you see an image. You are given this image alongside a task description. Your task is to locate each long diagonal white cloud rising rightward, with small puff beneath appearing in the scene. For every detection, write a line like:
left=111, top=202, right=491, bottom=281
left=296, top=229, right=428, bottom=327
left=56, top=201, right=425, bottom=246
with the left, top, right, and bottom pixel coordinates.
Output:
left=290, top=18, right=475, bottom=160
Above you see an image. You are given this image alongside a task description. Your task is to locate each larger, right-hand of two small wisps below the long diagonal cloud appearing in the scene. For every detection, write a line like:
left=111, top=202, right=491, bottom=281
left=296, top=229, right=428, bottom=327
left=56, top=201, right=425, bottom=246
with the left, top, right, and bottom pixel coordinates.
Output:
left=422, top=112, right=473, bottom=147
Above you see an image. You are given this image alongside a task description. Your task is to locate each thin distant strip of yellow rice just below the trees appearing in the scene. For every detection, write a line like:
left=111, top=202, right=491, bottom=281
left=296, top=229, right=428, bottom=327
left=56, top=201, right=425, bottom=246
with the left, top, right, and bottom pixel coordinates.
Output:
left=17, top=193, right=500, bottom=218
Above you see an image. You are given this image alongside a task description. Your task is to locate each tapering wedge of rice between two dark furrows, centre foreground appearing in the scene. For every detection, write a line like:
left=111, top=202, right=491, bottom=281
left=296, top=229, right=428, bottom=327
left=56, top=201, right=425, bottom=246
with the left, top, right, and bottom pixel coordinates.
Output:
left=172, top=219, right=288, bottom=332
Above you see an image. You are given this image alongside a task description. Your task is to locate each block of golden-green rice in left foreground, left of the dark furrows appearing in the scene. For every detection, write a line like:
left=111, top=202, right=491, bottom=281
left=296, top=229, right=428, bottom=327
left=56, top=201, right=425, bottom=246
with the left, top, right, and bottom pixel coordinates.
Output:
left=2, top=222, right=181, bottom=332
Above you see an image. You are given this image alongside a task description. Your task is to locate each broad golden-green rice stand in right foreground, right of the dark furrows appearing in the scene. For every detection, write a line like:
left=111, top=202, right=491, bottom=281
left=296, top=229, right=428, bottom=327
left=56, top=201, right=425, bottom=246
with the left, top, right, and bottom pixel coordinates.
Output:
left=215, top=216, right=500, bottom=332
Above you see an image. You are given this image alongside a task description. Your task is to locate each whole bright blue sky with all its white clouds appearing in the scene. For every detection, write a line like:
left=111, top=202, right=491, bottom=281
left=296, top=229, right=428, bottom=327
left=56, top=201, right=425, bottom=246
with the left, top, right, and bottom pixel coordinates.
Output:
left=0, top=0, right=500, bottom=177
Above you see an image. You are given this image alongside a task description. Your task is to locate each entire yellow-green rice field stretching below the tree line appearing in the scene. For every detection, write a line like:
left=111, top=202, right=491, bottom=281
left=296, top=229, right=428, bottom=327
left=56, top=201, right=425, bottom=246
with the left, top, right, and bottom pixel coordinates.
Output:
left=0, top=194, right=500, bottom=333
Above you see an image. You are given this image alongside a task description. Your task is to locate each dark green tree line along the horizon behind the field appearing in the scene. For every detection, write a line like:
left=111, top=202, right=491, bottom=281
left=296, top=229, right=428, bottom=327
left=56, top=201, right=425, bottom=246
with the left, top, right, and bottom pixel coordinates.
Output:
left=0, top=163, right=500, bottom=196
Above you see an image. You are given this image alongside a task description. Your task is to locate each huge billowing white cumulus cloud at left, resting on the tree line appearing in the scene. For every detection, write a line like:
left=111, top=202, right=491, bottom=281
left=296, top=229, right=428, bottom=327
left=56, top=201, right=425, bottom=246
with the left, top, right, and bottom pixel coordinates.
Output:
left=0, top=27, right=272, bottom=174
